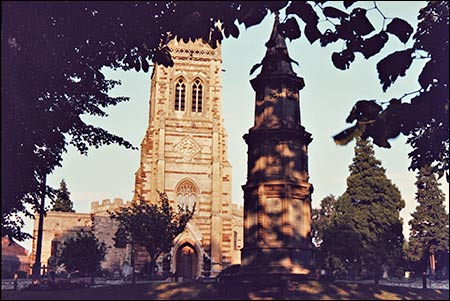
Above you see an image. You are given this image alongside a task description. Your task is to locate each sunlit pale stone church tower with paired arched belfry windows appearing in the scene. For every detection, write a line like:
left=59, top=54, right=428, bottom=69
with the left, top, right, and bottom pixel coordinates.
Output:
left=134, top=40, right=242, bottom=278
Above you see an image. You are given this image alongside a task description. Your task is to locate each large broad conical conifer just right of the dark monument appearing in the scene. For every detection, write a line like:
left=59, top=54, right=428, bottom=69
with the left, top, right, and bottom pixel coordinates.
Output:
left=321, top=139, right=405, bottom=277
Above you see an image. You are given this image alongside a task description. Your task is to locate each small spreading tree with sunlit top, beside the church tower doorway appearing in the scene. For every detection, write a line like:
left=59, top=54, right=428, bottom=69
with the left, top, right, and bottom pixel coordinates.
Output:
left=110, top=192, right=195, bottom=271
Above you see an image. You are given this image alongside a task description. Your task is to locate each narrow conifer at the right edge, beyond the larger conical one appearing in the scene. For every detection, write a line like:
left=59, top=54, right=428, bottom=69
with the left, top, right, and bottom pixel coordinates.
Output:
left=408, top=167, right=449, bottom=276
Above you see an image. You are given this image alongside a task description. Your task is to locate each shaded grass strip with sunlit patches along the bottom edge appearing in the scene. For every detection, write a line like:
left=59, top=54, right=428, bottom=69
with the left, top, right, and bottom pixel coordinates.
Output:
left=2, top=281, right=449, bottom=300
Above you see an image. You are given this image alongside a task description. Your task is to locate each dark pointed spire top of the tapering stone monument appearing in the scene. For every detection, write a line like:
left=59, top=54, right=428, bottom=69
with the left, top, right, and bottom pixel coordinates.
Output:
left=253, top=12, right=298, bottom=75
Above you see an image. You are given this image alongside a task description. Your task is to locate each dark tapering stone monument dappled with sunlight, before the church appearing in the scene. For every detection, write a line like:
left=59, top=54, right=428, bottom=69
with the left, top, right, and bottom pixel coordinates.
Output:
left=241, top=15, right=314, bottom=279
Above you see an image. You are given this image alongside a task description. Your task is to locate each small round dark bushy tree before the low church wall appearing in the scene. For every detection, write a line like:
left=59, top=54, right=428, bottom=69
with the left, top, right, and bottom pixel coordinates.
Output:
left=58, top=232, right=106, bottom=276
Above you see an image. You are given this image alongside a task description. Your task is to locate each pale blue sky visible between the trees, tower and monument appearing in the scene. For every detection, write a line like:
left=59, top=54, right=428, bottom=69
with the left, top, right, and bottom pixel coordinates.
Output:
left=21, top=1, right=449, bottom=250
